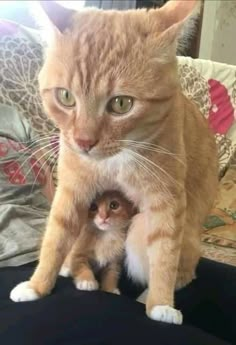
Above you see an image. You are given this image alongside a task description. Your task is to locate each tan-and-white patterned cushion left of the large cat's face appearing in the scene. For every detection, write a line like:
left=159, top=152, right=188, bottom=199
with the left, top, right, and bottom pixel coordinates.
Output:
left=0, top=20, right=57, bottom=176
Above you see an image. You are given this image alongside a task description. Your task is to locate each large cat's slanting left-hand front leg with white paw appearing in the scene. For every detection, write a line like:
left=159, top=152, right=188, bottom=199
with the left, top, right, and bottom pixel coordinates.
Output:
left=10, top=189, right=87, bottom=302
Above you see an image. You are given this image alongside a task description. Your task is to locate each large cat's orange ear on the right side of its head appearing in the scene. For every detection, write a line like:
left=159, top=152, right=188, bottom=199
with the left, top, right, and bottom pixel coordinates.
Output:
left=153, top=0, right=201, bottom=62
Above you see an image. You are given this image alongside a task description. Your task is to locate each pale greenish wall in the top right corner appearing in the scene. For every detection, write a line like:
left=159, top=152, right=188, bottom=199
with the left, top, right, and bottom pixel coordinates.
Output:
left=199, top=0, right=236, bottom=65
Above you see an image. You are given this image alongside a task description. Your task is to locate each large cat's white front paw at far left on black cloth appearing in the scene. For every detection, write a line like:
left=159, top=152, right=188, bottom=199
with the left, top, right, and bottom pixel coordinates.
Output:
left=10, top=281, right=40, bottom=302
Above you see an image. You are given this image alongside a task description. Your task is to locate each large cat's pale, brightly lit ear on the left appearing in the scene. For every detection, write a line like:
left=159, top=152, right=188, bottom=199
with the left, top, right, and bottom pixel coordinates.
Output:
left=32, top=0, right=76, bottom=43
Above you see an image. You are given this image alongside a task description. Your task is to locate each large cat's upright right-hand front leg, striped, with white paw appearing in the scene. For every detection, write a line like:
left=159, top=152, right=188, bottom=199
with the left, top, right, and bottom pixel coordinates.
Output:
left=146, top=190, right=186, bottom=324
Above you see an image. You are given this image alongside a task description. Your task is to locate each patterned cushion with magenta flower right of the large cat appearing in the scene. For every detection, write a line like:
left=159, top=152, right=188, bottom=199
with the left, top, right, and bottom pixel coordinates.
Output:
left=178, top=57, right=236, bottom=177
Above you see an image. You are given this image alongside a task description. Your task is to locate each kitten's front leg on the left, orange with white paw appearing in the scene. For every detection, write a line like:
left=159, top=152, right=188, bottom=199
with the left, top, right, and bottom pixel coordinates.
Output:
left=71, top=251, right=98, bottom=291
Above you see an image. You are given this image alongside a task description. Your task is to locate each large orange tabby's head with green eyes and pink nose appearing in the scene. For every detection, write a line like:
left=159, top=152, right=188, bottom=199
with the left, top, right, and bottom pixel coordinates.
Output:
left=39, top=0, right=197, bottom=159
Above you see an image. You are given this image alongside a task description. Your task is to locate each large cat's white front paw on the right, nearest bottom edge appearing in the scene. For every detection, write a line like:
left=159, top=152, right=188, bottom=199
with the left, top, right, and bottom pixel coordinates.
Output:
left=149, top=305, right=183, bottom=325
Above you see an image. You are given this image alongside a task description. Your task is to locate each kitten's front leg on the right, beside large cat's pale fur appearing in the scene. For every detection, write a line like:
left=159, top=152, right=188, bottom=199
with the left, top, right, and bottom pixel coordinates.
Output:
left=101, top=262, right=120, bottom=294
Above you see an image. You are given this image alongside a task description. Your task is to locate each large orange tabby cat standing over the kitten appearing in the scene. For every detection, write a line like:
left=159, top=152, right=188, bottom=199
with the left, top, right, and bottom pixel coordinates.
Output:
left=10, top=0, right=217, bottom=324
